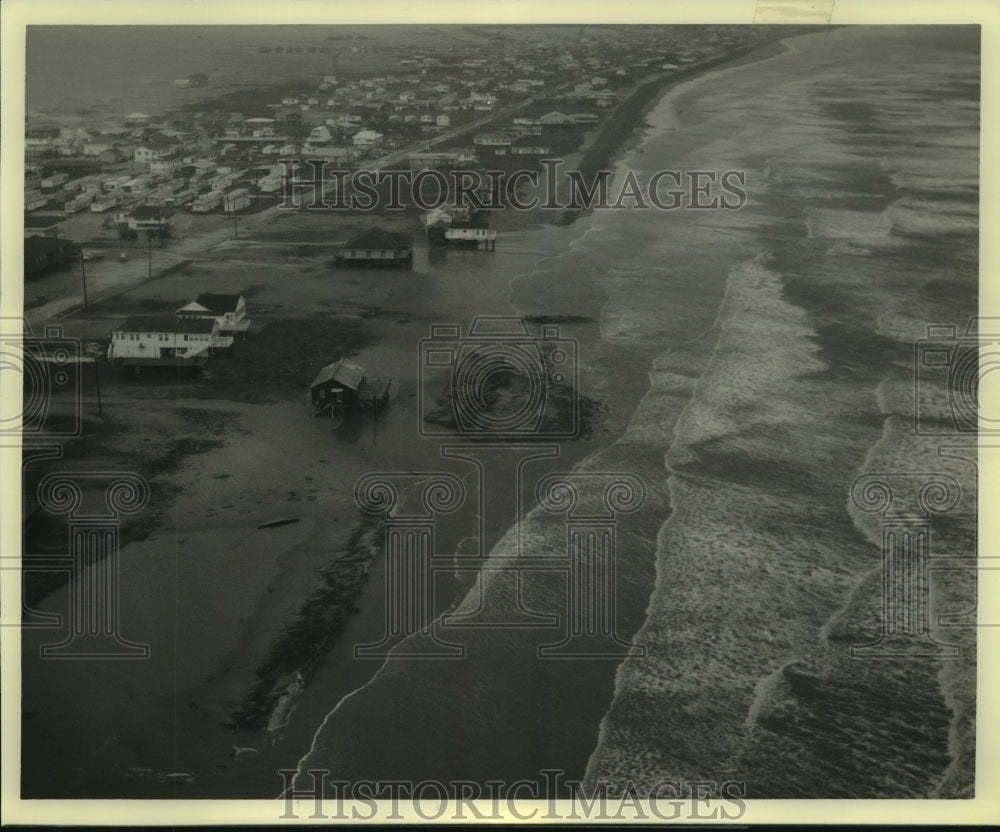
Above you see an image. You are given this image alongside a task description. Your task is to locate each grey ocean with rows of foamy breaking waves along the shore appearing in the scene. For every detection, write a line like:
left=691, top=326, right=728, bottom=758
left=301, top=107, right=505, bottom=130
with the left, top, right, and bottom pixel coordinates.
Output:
left=292, top=27, right=979, bottom=798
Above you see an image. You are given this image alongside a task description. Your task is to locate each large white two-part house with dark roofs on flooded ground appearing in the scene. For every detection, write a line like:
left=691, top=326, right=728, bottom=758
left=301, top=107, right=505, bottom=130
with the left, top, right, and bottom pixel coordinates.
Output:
left=108, top=292, right=250, bottom=367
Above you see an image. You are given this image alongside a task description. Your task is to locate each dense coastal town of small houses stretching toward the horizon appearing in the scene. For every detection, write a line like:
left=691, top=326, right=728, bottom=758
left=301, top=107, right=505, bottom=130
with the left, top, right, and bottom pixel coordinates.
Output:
left=24, top=26, right=788, bottom=303
